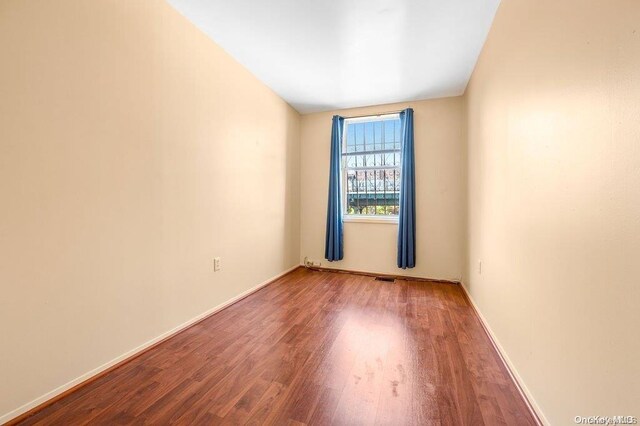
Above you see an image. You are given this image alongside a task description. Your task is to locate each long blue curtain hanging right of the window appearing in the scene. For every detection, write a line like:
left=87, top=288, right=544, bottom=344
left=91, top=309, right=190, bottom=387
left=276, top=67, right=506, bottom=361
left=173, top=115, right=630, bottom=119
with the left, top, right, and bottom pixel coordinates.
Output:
left=398, top=108, right=416, bottom=269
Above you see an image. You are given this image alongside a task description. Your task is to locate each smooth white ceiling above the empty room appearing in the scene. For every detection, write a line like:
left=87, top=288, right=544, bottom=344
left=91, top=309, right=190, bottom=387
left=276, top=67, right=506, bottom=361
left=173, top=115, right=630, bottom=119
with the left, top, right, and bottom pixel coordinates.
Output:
left=168, top=0, right=500, bottom=113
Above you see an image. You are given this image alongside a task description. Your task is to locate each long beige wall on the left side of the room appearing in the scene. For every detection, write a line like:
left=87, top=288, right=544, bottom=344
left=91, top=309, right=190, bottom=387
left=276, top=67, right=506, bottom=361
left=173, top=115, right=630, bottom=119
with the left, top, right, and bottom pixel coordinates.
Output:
left=0, top=0, right=300, bottom=422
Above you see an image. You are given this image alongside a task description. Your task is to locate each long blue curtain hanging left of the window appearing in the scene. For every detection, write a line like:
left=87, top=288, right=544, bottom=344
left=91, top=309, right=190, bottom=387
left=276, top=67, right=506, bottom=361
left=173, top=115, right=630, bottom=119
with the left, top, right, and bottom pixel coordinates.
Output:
left=324, top=115, right=344, bottom=262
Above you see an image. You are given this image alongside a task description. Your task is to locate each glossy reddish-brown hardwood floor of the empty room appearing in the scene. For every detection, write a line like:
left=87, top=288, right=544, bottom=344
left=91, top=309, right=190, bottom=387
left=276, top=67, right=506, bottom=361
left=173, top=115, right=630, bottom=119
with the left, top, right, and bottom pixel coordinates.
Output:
left=13, top=269, right=535, bottom=425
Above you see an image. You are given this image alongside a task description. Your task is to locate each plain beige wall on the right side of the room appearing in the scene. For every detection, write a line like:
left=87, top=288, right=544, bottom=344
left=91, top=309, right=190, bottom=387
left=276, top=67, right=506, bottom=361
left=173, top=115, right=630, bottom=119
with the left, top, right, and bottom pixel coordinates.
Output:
left=466, top=0, right=640, bottom=425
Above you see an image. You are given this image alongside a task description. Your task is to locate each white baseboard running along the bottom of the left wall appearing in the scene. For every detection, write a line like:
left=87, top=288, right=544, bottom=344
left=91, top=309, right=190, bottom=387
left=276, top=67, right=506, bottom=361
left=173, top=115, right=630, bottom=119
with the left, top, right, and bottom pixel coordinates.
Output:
left=0, top=265, right=300, bottom=424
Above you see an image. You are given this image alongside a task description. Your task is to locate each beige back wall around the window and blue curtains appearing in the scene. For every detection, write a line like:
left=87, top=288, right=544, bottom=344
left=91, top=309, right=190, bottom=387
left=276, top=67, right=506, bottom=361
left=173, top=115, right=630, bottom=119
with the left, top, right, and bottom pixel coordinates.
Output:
left=300, top=97, right=466, bottom=280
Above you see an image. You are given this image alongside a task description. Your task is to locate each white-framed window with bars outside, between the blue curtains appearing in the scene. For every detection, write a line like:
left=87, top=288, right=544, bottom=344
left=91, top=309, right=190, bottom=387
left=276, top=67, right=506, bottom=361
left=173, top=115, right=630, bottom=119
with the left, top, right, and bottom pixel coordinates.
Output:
left=342, top=114, right=400, bottom=221
